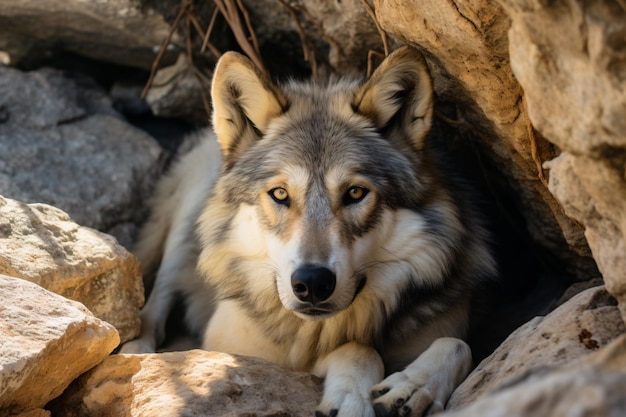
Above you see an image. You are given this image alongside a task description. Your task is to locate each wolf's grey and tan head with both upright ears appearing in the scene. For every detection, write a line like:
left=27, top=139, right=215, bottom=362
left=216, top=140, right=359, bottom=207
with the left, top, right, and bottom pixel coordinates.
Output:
left=200, top=47, right=440, bottom=319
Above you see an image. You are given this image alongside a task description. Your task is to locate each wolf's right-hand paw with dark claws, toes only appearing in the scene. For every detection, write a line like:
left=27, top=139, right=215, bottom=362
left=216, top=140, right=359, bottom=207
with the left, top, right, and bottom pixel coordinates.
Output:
left=370, top=372, right=443, bottom=417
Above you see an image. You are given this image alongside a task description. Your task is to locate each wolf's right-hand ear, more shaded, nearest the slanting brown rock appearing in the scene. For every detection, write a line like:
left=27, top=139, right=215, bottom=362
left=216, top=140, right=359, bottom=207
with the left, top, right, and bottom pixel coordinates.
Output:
left=353, top=46, right=433, bottom=149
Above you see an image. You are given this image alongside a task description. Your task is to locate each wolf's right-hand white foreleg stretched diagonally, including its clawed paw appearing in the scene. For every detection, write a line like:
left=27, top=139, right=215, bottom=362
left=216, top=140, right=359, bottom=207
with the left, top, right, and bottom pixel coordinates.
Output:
left=371, top=337, right=472, bottom=417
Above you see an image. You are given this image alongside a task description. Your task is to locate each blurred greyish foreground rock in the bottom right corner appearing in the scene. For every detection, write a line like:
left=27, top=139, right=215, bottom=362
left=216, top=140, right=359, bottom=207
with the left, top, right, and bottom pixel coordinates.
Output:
left=441, top=335, right=626, bottom=417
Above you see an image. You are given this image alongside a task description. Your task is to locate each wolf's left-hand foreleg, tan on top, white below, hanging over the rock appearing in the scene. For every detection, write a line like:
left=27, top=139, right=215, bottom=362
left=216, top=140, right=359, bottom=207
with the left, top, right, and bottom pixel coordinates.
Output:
left=313, top=342, right=384, bottom=417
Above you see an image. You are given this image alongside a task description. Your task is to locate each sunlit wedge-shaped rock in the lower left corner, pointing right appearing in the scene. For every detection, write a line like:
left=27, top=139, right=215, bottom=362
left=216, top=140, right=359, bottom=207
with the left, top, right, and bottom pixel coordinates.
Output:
left=0, top=275, right=120, bottom=417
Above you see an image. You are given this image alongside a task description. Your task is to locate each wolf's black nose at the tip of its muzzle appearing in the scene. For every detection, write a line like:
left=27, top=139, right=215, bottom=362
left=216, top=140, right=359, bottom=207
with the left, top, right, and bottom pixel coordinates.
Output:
left=291, top=265, right=337, bottom=304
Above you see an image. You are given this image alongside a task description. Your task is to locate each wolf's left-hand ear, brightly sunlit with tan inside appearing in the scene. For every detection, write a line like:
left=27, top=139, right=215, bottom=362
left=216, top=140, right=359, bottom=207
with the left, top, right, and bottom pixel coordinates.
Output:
left=211, top=52, right=287, bottom=157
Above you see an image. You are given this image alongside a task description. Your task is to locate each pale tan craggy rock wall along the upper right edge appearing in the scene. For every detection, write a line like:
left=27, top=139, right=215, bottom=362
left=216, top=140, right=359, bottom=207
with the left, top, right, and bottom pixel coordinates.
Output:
left=500, top=0, right=626, bottom=318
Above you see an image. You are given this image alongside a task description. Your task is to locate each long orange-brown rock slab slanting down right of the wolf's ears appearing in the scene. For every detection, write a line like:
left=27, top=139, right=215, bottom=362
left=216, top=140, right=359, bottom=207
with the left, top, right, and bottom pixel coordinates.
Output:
left=374, top=0, right=597, bottom=279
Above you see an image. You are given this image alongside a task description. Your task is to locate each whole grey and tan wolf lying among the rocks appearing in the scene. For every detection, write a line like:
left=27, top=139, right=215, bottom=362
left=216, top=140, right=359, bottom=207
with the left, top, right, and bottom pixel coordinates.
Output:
left=122, top=46, right=497, bottom=417
